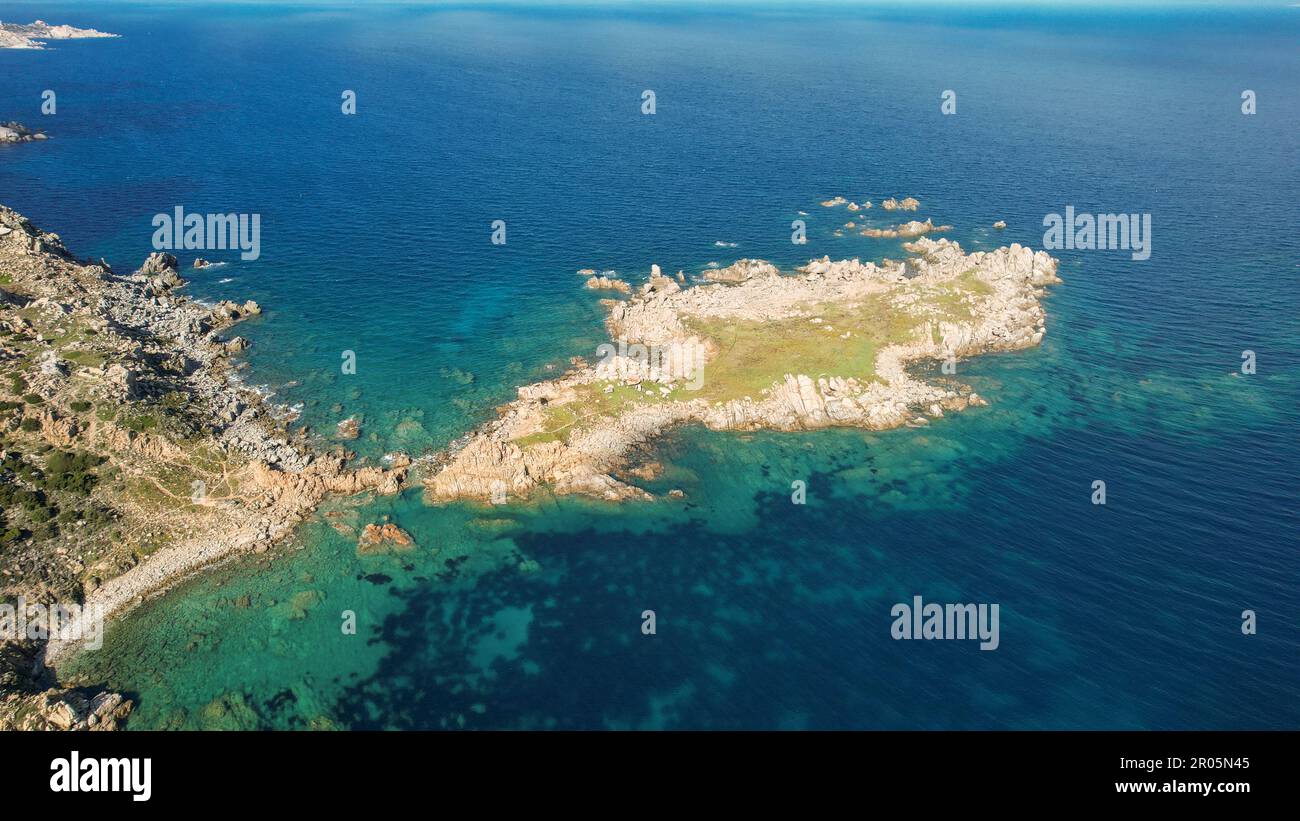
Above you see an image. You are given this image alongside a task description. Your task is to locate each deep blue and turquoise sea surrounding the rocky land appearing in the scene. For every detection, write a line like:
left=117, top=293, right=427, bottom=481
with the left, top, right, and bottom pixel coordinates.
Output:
left=0, top=3, right=1300, bottom=729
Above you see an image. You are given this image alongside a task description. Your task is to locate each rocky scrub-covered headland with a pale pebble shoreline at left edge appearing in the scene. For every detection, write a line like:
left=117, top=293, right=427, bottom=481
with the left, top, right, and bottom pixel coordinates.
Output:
left=0, top=207, right=410, bottom=729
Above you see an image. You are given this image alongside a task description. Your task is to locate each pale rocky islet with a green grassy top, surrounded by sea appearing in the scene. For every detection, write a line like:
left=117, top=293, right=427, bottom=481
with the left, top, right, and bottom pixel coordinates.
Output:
left=424, top=227, right=1058, bottom=503
